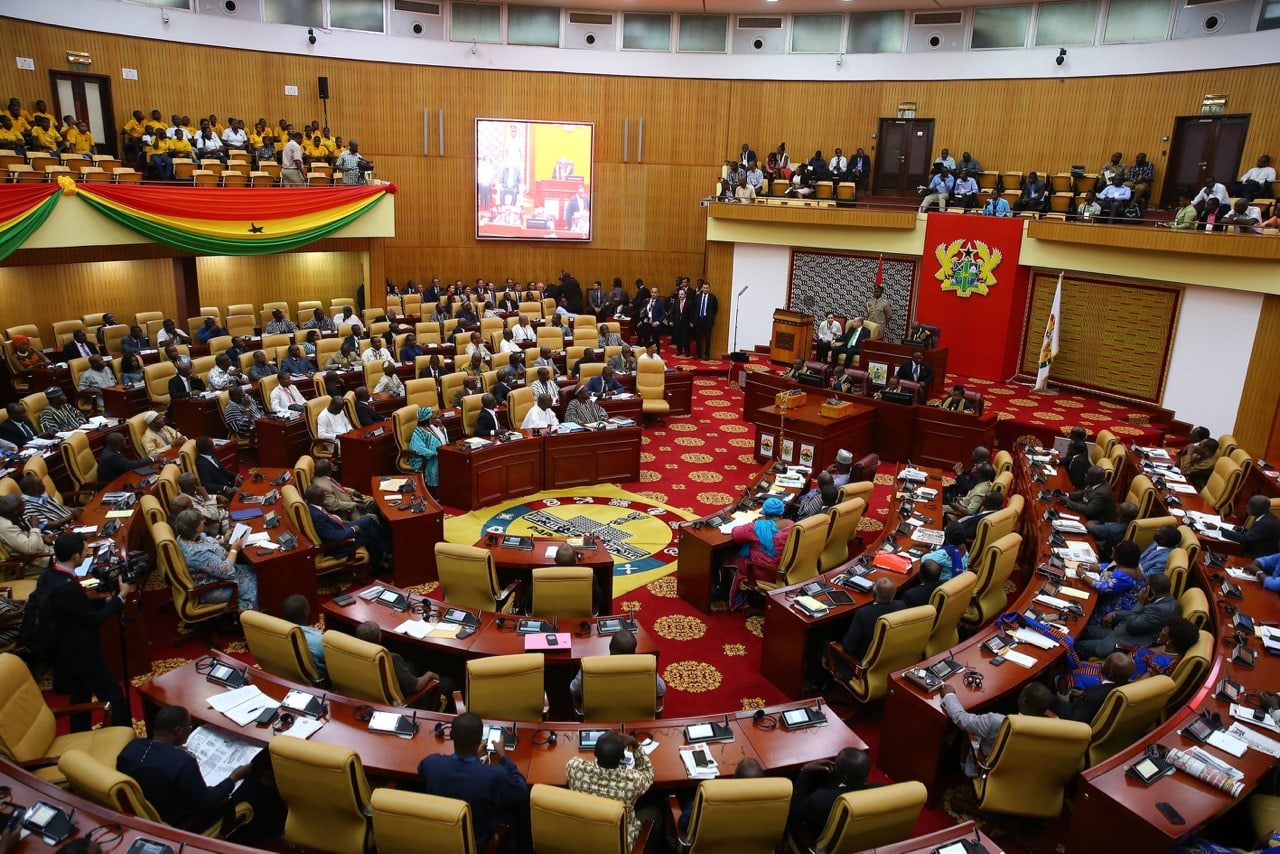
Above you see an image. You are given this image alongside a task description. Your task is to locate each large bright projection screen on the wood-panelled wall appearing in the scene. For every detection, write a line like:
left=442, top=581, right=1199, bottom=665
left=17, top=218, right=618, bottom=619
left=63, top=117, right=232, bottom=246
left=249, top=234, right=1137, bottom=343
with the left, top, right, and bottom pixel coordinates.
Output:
left=476, top=119, right=595, bottom=241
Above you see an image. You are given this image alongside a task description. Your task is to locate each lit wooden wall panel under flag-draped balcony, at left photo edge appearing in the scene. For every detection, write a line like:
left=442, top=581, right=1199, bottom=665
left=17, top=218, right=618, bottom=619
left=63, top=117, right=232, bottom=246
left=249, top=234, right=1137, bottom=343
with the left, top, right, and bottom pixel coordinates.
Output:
left=0, top=259, right=174, bottom=346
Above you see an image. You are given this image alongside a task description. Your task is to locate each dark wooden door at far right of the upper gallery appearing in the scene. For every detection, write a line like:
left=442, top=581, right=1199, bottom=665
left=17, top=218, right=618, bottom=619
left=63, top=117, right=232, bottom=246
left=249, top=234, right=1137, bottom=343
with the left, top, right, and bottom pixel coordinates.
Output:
left=1160, top=115, right=1249, bottom=207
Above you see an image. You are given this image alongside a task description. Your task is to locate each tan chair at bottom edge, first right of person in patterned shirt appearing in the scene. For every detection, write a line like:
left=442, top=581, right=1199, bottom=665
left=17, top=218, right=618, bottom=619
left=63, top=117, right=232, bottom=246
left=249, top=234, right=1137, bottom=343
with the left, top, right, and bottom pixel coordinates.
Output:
left=668, top=777, right=791, bottom=854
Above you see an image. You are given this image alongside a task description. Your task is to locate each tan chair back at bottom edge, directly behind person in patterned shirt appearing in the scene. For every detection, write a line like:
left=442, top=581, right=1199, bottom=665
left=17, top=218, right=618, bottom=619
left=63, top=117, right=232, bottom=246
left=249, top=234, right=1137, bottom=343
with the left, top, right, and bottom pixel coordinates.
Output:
left=529, top=784, right=649, bottom=854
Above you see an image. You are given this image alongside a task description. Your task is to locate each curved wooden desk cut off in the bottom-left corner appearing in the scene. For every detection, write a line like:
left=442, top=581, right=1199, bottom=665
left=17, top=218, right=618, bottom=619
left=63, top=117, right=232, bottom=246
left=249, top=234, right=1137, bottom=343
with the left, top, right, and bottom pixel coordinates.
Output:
left=0, top=758, right=259, bottom=854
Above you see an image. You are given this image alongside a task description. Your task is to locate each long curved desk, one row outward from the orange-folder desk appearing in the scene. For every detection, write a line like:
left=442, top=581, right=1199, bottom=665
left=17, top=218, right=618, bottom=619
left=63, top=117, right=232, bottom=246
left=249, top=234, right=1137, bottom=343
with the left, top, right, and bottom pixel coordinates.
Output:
left=878, top=452, right=1097, bottom=798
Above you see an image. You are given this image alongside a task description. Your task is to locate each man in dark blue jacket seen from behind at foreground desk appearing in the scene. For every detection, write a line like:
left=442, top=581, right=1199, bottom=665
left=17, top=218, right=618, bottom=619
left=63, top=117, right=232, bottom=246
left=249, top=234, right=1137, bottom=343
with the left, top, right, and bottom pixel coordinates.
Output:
left=417, top=712, right=529, bottom=850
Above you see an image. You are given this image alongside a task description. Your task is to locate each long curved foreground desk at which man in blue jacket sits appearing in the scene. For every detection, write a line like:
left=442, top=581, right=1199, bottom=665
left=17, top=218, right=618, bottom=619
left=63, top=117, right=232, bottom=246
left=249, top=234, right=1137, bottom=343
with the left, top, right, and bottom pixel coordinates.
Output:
left=140, top=656, right=867, bottom=787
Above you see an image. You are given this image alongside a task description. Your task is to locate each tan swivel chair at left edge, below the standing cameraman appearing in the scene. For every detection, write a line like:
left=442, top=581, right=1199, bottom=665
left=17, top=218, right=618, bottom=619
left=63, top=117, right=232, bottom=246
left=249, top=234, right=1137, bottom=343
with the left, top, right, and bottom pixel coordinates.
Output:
left=0, top=653, right=134, bottom=782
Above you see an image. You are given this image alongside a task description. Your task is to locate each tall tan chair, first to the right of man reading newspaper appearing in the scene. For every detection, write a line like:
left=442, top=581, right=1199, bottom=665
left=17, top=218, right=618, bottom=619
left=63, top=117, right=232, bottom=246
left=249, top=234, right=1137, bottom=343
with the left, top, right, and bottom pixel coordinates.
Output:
left=269, top=737, right=374, bottom=854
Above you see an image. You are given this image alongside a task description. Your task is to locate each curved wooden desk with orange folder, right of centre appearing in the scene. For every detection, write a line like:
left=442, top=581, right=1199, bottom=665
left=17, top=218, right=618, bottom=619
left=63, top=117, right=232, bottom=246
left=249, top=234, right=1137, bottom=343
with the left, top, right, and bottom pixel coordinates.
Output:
left=760, top=471, right=942, bottom=701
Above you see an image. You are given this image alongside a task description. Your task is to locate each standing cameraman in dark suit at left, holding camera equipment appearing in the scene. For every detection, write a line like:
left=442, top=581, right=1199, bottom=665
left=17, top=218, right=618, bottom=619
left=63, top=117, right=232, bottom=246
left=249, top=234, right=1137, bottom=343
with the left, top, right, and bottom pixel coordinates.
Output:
left=38, top=534, right=133, bottom=732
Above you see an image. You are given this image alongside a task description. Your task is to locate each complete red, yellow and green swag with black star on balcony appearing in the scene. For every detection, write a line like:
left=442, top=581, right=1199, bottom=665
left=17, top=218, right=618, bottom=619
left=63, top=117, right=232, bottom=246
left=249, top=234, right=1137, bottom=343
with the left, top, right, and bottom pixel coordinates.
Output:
left=64, top=184, right=396, bottom=255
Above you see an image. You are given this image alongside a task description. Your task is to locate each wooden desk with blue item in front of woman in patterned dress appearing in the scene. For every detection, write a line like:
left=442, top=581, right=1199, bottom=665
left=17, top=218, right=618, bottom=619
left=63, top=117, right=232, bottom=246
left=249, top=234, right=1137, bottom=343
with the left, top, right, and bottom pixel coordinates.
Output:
left=229, top=466, right=320, bottom=617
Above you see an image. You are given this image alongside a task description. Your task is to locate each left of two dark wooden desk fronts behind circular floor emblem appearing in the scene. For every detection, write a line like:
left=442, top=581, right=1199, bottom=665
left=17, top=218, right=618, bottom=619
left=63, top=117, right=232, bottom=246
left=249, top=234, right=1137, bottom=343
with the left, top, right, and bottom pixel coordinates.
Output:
left=439, top=438, right=543, bottom=510
